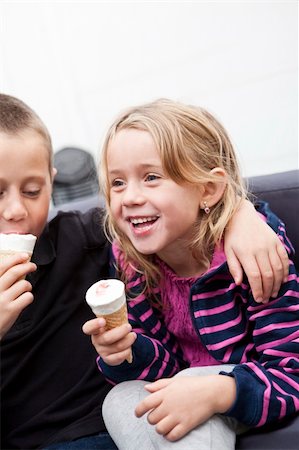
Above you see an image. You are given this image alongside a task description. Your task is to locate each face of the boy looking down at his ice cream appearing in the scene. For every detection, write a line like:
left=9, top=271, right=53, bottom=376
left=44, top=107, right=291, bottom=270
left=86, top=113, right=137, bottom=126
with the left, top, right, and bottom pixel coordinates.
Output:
left=0, top=129, right=52, bottom=237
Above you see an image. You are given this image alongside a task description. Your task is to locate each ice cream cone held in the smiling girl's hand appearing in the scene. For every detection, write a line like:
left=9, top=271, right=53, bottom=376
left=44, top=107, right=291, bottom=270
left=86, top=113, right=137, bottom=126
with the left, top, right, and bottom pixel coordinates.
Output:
left=86, top=279, right=132, bottom=363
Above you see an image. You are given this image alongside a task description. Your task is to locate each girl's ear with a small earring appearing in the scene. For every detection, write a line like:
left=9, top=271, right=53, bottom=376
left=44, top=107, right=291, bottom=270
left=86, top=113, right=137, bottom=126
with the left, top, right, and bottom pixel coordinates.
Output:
left=200, top=167, right=226, bottom=209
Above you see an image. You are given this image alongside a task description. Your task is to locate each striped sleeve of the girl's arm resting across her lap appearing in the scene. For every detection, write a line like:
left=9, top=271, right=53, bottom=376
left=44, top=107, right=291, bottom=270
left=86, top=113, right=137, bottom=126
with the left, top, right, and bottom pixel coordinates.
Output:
left=227, top=264, right=299, bottom=427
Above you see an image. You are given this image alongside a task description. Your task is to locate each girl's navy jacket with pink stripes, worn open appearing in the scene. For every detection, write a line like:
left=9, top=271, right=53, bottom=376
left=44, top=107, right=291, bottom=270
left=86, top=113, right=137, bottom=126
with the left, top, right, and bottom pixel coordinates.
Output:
left=98, top=205, right=299, bottom=426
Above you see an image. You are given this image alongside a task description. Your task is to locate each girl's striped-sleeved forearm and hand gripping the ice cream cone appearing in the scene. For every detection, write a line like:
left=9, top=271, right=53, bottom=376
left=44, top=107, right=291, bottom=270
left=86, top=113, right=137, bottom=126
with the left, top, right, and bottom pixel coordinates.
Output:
left=83, top=288, right=183, bottom=383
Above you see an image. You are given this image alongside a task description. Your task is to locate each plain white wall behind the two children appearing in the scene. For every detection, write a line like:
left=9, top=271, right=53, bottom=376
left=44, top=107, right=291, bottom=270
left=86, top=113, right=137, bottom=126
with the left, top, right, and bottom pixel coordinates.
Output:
left=0, top=0, right=299, bottom=175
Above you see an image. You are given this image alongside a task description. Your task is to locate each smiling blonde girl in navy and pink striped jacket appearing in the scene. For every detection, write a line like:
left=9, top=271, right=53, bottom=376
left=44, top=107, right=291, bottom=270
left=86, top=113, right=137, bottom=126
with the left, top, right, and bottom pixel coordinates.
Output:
left=84, top=100, right=299, bottom=450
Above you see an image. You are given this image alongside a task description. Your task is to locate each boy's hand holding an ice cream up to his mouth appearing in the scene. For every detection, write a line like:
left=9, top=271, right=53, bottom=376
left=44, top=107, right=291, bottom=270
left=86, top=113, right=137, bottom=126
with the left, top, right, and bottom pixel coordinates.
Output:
left=0, top=253, right=37, bottom=339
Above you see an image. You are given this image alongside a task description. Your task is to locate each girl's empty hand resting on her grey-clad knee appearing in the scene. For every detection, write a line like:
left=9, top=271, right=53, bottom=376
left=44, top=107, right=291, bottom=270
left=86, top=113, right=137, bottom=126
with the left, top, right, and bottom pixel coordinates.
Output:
left=135, top=375, right=236, bottom=441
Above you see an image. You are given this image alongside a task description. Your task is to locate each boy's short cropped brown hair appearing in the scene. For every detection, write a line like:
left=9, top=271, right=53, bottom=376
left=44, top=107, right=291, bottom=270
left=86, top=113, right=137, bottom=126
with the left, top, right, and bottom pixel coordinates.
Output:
left=0, top=93, right=53, bottom=172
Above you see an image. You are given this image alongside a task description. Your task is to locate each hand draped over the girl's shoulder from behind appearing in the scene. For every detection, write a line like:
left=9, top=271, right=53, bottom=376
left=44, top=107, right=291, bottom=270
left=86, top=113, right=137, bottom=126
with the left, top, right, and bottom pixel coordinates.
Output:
left=224, top=200, right=289, bottom=303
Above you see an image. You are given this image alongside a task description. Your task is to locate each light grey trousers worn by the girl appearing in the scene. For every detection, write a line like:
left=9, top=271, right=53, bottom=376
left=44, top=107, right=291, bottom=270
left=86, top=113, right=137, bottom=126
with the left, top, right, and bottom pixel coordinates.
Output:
left=103, top=365, right=247, bottom=450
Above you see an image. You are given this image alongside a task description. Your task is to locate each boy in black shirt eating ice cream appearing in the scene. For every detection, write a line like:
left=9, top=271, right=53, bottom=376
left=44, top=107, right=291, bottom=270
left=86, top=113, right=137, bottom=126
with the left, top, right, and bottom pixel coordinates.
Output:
left=0, top=94, right=116, bottom=450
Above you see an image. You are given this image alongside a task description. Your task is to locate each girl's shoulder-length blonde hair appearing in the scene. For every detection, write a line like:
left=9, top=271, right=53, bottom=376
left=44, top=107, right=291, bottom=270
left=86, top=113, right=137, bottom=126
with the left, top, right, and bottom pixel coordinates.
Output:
left=100, top=99, right=246, bottom=290
